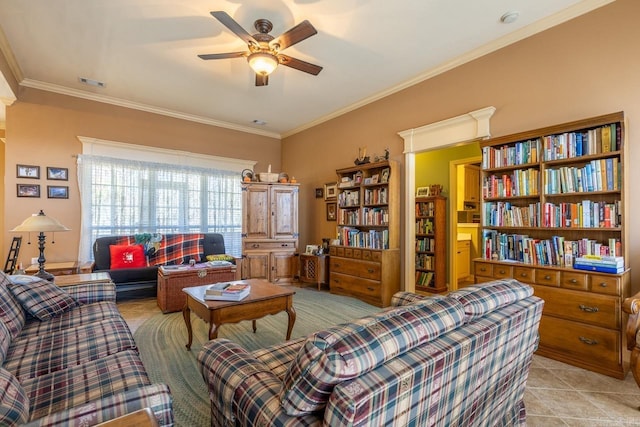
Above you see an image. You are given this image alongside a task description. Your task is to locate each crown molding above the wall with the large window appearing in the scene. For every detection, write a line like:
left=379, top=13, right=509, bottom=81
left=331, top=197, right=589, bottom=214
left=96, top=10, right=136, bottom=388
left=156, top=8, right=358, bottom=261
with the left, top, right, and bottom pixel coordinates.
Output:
left=20, top=79, right=281, bottom=139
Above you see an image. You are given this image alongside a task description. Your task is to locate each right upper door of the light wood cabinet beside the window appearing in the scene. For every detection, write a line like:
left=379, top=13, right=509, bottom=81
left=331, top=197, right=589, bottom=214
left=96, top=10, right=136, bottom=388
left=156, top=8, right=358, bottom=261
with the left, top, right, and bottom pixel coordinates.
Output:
left=270, top=185, right=298, bottom=239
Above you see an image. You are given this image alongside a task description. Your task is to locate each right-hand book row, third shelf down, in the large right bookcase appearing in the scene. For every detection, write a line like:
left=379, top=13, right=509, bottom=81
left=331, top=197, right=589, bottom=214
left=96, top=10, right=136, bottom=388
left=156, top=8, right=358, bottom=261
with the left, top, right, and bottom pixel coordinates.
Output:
left=542, top=200, right=622, bottom=228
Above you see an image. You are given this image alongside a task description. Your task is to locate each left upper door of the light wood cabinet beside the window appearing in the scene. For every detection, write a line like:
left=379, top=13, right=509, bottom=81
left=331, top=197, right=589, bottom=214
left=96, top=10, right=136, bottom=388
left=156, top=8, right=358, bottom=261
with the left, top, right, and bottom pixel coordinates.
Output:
left=242, top=184, right=271, bottom=239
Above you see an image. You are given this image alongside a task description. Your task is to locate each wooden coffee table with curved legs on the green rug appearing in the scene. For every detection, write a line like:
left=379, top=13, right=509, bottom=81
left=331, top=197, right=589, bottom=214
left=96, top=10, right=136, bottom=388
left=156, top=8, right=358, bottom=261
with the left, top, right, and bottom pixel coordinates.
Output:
left=182, top=279, right=296, bottom=350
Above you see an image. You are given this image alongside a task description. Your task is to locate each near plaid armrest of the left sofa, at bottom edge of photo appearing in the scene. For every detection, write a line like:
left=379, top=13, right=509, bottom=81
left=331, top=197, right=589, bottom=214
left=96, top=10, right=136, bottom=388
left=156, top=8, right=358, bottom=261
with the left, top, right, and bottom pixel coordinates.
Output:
left=25, top=384, right=173, bottom=427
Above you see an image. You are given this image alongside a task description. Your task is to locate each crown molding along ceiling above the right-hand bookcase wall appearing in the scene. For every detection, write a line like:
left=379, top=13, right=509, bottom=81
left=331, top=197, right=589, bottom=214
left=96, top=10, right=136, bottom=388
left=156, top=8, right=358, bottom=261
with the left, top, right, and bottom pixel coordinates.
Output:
left=282, top=0, right=615, bottom=138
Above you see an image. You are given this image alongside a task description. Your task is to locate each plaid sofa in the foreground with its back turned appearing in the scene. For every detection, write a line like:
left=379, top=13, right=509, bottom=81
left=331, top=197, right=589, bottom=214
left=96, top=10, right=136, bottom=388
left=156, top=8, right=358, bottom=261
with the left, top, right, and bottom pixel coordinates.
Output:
left=198, top=280, right=543, bottom=427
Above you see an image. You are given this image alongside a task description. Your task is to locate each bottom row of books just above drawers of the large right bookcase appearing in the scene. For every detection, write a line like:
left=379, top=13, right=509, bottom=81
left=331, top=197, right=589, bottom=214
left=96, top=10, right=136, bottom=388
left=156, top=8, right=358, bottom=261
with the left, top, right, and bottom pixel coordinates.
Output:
left=482, top=230, right=624, bottom=267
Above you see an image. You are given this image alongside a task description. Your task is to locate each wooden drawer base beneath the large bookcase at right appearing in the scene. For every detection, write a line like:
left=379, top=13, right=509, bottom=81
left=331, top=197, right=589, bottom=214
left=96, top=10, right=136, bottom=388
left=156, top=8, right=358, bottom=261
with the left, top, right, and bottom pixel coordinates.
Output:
left=474, top=260, right=631, bottom=379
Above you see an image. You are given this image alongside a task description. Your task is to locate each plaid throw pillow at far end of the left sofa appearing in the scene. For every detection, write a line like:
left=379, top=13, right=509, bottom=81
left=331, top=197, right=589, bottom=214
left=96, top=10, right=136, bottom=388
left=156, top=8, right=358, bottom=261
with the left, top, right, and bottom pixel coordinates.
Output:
left=9, top=279, right=78, bottom=320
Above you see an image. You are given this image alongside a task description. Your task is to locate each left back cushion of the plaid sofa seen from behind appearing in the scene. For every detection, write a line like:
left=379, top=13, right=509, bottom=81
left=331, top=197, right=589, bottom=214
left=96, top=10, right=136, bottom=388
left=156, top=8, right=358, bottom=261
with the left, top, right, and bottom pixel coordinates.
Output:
left=280, top=298, right=464, bottom=416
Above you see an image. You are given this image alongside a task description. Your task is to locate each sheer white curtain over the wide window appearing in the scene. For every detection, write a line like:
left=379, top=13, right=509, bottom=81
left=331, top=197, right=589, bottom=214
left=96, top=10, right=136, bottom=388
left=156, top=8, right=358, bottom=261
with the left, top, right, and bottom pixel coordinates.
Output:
left=78, top=154, right=242, bottom=261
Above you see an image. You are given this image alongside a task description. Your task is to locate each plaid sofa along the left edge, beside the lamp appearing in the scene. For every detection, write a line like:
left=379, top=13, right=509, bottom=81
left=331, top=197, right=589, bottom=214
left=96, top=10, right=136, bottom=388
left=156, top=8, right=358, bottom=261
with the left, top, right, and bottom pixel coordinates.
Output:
left=0, top=272, right=173, bottom=426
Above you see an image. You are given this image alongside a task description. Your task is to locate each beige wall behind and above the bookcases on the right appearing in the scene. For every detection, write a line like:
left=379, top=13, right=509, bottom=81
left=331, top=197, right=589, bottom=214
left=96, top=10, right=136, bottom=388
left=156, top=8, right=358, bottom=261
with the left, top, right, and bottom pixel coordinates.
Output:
left=283, top=0, right=640, bottom=290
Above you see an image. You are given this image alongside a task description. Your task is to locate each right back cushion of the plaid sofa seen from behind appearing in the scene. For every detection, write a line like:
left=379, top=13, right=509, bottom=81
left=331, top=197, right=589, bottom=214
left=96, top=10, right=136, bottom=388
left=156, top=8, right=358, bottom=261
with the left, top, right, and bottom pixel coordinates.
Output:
left=448, top=279, right=533, bottom=322
